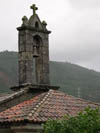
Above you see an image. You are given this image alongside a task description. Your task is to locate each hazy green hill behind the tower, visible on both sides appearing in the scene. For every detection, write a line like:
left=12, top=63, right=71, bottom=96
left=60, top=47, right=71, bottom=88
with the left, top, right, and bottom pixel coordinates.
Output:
left=0, top=51, right=100, bottom=102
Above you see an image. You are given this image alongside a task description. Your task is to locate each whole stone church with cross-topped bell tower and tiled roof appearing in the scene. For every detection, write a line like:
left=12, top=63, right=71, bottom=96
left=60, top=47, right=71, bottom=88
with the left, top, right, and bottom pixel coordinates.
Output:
left=0, top=4, right=99, bottom=133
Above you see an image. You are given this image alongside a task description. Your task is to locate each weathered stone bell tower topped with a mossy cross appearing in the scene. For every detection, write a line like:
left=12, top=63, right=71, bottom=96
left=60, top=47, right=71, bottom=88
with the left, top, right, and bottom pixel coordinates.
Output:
left=17, top=4, right=51, bottom=85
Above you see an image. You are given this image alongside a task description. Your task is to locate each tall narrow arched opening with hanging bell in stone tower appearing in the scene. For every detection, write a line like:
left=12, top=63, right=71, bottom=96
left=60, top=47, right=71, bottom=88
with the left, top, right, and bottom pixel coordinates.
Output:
left=33, top=35, right=43, bottom=84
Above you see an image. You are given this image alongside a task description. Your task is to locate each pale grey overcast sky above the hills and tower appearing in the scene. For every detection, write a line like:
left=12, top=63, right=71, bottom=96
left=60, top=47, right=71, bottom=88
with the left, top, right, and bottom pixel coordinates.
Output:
left=0, top=0, right=100, bottom=71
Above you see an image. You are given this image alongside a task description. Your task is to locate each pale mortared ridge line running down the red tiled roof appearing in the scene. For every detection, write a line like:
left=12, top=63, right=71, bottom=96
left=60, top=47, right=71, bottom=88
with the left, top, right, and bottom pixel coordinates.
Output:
left=28, top=90, right=52, bottom=118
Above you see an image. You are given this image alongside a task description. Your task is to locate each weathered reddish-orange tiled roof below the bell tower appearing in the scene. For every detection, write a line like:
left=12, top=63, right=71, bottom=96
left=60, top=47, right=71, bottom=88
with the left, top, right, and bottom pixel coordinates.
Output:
left=0, top=90, right=99, bottom=123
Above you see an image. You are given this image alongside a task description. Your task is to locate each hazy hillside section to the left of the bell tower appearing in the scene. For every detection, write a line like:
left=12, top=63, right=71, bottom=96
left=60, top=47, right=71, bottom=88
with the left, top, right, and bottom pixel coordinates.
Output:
left=0, top=51, right=18, bottom=93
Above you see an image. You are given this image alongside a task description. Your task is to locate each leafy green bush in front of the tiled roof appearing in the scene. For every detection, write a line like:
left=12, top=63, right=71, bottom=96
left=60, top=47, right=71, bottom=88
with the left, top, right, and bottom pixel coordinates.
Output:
left=44, top=108, right=100, bottom=133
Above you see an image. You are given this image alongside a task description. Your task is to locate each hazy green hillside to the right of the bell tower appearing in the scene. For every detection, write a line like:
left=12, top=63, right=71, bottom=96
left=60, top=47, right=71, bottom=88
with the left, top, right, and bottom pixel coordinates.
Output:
left=50, top=62, right=100, bottom=102
